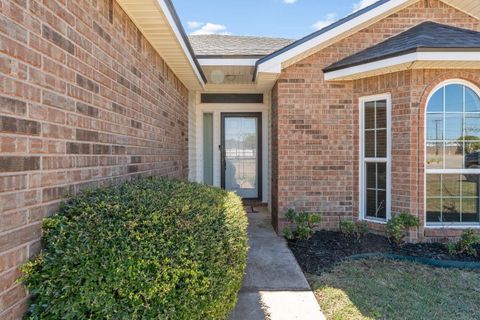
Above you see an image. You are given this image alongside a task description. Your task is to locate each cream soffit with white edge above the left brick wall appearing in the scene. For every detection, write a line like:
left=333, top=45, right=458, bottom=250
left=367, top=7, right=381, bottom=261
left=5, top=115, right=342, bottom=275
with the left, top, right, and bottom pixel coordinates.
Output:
left=117, top=0, right=205, bottom=90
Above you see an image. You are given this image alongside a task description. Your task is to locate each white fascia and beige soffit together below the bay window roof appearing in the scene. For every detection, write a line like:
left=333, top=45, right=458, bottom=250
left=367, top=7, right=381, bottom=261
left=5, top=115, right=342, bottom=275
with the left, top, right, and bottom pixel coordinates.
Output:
left=324, top=51, right=480, bottom=81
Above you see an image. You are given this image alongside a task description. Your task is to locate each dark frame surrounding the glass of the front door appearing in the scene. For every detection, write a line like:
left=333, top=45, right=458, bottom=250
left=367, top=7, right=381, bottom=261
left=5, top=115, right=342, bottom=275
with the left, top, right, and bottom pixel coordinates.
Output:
left=220, top=112, right=263, bottom=201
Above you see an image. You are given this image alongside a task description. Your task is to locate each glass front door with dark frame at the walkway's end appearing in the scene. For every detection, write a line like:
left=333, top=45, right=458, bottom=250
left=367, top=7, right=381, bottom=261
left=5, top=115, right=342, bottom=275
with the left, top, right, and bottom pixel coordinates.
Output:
left=221, top=113, right=262, bottom=199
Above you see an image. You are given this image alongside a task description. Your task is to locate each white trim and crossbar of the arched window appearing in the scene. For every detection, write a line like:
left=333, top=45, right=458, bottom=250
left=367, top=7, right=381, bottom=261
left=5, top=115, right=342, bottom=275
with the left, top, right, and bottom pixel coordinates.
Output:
left=423, top=79, right=480, bottom=229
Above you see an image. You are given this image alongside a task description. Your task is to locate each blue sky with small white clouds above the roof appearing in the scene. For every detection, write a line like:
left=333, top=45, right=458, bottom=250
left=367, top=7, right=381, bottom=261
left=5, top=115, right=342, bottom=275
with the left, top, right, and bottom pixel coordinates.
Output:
left=173, top=0, right=376, bottom=39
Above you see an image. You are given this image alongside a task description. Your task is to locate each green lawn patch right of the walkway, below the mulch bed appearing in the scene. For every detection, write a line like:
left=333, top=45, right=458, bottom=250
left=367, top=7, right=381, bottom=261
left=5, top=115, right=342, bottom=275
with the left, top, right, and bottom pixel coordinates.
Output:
left=309, top=259, right=480, bottom=320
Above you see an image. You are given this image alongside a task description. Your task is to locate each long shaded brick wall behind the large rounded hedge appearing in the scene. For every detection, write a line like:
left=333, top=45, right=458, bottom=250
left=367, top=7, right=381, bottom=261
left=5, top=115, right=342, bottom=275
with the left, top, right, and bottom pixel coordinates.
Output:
left=0, top=0, right=188, bottom=319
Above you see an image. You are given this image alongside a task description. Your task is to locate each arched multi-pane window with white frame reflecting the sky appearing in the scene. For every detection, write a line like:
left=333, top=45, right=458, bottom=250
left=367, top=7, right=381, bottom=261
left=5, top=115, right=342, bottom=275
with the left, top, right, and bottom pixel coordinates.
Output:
left=426, top=80, right=480, bottom=225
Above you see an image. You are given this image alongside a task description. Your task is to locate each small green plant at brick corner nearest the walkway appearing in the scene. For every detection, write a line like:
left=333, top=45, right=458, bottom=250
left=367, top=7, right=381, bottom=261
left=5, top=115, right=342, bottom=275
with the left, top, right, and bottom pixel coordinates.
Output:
left=284, top=209, right=320, bottom=240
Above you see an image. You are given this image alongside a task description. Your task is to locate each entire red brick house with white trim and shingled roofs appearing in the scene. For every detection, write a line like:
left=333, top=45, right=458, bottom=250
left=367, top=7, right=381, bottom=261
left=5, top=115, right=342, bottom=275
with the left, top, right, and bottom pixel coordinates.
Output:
left=0, top=0, right=480, bottom=319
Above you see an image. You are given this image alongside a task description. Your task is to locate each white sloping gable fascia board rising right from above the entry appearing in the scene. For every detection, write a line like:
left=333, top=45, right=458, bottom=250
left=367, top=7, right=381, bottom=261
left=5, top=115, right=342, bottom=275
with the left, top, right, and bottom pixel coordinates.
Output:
left=257, top=0, right=410, bottom=73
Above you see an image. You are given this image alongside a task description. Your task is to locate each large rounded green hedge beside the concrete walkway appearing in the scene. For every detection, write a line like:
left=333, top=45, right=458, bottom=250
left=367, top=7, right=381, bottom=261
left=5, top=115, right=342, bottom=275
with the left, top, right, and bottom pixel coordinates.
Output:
left=21, top=179, right=247, bottom=320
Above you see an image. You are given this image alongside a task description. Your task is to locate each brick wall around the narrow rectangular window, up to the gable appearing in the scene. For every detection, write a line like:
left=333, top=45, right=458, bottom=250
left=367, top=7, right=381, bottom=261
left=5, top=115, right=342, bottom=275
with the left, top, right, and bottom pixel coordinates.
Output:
left=272, top=0, right=480, bottom=238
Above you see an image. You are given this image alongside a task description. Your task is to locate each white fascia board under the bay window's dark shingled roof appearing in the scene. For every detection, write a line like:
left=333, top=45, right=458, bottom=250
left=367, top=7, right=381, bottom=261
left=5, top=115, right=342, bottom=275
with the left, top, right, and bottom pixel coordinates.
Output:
left=324, top=51, right=480, bottom=81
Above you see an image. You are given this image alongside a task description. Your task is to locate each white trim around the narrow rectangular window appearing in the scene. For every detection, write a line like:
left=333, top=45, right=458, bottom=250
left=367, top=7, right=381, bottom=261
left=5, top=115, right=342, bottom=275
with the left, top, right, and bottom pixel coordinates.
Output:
left=359, top=93, right=392, bottom=224
